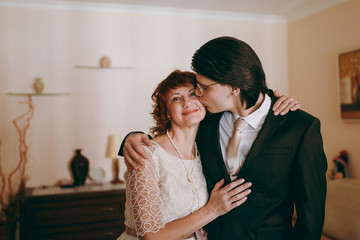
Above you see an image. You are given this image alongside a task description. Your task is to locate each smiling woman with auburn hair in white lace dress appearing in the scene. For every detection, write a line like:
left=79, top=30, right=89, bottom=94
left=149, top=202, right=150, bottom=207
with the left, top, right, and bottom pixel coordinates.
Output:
left=119, top=70, right=251, bottom=240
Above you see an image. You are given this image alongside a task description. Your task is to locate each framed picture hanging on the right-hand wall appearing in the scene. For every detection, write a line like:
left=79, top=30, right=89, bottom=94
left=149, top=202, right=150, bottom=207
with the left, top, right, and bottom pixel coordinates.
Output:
left=338, top=49, right=360, bottom=119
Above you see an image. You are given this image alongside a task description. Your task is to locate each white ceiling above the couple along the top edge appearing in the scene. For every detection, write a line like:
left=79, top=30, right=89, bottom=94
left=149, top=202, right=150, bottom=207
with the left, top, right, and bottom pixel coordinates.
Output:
left=0, top=0, right=348, bottom=21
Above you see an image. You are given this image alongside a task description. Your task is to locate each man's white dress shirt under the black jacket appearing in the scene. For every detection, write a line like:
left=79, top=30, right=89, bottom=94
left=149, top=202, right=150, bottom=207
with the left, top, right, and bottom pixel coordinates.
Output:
left=219, top=95, right=271, bottom=171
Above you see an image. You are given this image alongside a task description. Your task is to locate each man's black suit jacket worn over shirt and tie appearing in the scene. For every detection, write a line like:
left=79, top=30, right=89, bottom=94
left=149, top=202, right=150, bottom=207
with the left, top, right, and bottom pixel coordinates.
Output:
left=196, top=94, right=327, bottom=240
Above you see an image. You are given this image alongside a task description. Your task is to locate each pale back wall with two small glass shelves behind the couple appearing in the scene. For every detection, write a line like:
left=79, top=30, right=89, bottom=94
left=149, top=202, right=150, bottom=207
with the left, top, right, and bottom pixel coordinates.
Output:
left=0, top=6, right=288, bottom=186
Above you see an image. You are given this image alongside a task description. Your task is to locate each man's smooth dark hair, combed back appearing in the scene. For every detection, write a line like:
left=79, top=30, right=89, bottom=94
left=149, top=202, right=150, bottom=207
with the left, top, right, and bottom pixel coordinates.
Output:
left=191, top=37, right=268, bottom=108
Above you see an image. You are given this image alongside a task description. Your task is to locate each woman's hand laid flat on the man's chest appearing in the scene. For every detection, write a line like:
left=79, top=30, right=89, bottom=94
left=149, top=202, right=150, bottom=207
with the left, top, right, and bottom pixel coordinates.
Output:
left=206, top=179, right=251, bottom=217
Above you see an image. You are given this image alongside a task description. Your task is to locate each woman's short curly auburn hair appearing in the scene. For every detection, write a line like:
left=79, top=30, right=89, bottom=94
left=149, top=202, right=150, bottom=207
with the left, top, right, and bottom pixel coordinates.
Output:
left=150, top=70, right=196, bottom=137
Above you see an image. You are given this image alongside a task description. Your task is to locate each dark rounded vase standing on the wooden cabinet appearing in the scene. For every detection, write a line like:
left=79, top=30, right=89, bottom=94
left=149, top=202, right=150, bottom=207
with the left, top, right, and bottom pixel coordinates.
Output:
left=70, top=149, right=89, bottom=186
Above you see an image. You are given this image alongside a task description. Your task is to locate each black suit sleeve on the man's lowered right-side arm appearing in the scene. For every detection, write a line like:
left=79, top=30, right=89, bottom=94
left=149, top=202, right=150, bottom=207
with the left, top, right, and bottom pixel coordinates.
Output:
left=292, top=119, right=327, bottom=240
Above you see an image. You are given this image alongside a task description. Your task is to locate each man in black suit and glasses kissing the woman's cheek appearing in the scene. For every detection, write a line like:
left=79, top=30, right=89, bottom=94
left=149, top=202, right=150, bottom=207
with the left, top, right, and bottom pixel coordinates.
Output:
left=120, top=37, right=327, bottom=240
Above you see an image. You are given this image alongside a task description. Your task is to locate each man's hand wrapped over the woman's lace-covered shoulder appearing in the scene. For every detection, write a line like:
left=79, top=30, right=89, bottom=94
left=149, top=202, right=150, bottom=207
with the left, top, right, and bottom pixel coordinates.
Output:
left=123, top=133, right=151, bottom=171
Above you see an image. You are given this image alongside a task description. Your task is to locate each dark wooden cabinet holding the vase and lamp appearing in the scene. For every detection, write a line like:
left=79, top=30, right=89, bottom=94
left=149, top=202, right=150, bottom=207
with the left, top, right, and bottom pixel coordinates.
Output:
left=20, top=184, right=125, bottom=240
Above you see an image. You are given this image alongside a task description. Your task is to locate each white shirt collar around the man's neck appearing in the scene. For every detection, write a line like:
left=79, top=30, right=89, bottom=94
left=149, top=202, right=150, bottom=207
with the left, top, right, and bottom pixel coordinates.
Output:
left=228, top=94, right=271, bottom=129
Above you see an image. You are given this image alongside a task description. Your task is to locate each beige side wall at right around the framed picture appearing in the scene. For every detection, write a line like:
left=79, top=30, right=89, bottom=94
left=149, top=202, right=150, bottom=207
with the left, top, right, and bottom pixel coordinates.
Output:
left=288, top=0, right=360, bottom=178
